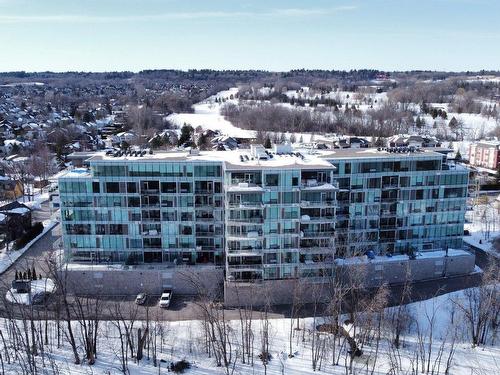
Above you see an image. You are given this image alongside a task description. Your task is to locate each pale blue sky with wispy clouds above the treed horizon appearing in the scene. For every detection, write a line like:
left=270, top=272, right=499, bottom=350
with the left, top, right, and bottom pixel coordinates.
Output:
left=0, top=0, right=500, bottom=72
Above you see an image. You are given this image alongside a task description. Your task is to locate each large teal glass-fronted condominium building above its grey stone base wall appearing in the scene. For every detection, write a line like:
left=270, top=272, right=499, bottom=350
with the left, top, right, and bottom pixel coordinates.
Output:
left=59, top=146, right=468, bottom=281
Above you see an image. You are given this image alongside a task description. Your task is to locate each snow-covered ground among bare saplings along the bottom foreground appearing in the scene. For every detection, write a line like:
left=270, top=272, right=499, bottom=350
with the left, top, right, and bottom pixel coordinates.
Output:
left=0, top=292, right=500, bottom=375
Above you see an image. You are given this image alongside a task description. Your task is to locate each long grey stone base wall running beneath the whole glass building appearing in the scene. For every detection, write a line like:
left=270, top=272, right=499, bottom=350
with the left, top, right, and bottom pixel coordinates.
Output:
left=60, top=250, right=475, bottom=306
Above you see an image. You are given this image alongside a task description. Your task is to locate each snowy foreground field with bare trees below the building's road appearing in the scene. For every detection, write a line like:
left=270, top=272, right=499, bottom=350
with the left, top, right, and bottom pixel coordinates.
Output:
left=0, top=291, right=500, bottom=375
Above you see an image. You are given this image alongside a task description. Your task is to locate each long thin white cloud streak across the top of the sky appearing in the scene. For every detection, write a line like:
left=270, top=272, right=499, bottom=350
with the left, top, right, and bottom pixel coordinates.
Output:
left=0, top=6, right=357, bottom=23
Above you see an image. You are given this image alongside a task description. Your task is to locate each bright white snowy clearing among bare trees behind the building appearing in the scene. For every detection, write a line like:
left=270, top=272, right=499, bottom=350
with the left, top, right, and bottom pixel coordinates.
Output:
left=167, top=87, right=255, bottom=138
